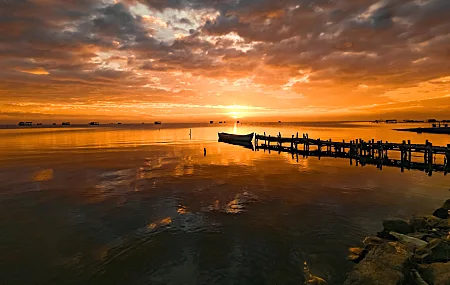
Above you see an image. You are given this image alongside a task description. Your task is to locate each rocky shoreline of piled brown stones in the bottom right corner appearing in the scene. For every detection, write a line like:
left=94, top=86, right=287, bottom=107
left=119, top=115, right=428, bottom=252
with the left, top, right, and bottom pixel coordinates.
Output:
left=344, top=199, right=450, bottom=285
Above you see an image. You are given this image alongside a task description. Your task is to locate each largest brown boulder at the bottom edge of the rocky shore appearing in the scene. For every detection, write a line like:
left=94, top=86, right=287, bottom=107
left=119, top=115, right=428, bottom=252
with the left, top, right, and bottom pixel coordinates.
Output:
left=344, top=242, right=412, bottom=285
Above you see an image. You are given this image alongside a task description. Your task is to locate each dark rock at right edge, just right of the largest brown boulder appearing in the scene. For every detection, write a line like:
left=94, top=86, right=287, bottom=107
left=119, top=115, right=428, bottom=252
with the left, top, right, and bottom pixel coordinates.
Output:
left=414, top=239, right=450, bottom=263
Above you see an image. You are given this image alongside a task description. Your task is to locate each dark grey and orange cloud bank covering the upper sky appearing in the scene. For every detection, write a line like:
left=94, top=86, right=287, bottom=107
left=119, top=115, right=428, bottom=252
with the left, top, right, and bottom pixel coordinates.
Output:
left=0, top=0, right=450, bottom=120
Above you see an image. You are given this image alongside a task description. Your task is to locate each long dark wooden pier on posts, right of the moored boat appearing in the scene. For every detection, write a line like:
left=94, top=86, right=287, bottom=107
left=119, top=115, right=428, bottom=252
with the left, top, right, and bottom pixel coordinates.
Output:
left=255, top=133, right=450, bottom=176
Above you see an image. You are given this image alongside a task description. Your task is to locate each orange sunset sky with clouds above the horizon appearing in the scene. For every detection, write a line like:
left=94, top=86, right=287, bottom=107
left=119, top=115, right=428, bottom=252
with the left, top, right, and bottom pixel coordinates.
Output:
left=0, top=0, right=450, bottom=123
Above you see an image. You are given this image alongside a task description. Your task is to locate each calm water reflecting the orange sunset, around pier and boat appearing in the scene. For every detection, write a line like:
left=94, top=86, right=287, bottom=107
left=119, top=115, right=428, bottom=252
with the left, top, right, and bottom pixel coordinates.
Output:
left=0, top=123, right=450, bottom=285
